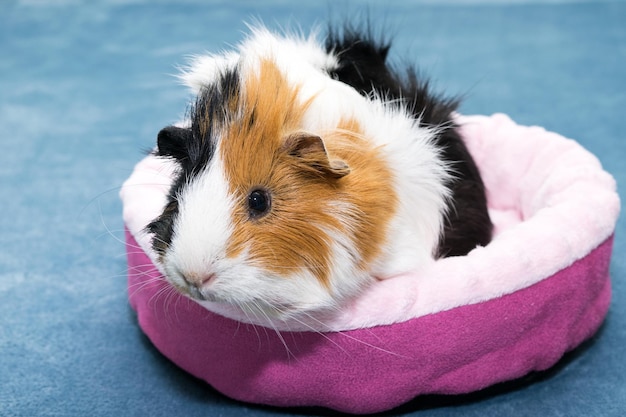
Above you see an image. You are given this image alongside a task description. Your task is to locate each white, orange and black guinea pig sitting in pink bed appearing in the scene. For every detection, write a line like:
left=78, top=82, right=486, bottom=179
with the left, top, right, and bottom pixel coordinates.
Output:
left=147, top=27, right=492, bottom=319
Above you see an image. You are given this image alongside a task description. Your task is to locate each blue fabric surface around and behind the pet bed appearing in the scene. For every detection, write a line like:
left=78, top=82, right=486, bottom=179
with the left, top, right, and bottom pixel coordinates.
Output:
left=0, top=0, right=626, bottom=416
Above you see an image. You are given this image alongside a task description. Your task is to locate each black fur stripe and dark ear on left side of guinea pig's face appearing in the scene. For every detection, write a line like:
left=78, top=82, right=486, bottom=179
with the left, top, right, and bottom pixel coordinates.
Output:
left=146, top=69, right=240, bottom=256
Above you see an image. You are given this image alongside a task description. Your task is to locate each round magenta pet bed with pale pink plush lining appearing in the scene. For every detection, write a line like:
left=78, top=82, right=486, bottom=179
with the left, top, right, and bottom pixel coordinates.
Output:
left=121, top=115, right=620, bottom=413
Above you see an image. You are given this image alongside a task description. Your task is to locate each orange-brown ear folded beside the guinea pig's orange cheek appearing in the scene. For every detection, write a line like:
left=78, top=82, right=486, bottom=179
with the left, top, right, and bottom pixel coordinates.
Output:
left=282, top=132, right=350, bottom=179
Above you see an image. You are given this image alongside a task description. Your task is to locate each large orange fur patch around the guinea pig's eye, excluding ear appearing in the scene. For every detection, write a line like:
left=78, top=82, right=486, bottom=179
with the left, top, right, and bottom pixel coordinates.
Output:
left=220, top=61, right=397, bottom=286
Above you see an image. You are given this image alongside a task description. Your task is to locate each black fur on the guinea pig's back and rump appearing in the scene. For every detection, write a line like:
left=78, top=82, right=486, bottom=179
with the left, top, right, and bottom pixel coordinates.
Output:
left=326, top=27, right=493, bottom=257
